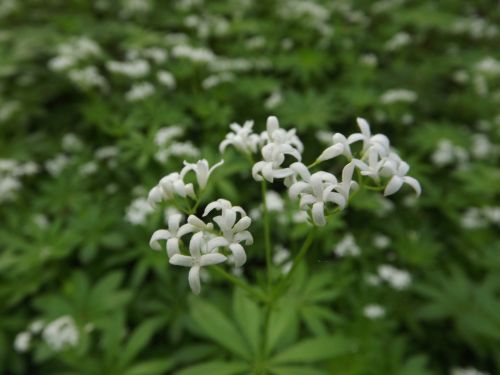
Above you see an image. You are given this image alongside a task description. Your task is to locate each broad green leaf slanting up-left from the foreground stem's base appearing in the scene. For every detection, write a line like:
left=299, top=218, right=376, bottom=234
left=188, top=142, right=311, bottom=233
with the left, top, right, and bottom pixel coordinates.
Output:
left=191, top=298, right=250, bottom=359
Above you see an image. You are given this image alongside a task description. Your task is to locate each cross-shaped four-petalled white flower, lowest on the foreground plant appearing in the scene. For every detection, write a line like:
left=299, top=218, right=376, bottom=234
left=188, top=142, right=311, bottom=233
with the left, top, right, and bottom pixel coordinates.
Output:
left=169, top=233, right=227, bottom=294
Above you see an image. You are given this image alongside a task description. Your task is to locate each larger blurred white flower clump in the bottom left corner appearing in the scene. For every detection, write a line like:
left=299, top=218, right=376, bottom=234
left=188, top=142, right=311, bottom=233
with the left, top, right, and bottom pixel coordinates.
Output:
left=42, top=315, right=80, bottom=351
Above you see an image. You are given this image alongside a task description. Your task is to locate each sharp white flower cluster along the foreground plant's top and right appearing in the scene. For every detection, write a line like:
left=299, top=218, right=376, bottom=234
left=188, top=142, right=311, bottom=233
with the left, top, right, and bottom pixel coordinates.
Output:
left=220, top=116, right=421, bottom=226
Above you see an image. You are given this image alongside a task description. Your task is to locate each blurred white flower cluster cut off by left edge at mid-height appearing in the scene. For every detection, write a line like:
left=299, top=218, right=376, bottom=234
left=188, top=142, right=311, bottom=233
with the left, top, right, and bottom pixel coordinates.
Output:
left=0, top=159, right=38, bottom=203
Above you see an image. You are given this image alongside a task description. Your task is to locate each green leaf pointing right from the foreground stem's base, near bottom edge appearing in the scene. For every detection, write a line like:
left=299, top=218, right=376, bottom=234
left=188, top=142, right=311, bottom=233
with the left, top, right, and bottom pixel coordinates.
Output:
left=272, top=336, right=351, bottom=363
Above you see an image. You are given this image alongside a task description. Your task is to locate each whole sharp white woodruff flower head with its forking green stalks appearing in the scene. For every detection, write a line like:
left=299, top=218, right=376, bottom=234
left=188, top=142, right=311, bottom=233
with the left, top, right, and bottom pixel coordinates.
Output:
left=148, top=116, right=421, bottom=298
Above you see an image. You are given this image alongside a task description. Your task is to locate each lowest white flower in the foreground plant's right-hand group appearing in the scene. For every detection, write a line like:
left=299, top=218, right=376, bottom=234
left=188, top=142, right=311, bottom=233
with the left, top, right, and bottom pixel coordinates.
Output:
left=289, top=162, right=347, bottom=226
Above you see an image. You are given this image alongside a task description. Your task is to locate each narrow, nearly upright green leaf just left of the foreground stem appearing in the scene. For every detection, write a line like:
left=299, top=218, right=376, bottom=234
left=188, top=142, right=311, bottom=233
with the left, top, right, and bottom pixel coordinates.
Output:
left=233, top=289, right=262, bottom=354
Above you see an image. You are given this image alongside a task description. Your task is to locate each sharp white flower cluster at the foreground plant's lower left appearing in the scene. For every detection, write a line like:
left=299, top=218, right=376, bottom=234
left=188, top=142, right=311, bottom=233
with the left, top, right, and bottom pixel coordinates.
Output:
left=150, top=199, right=253, bottom=294
